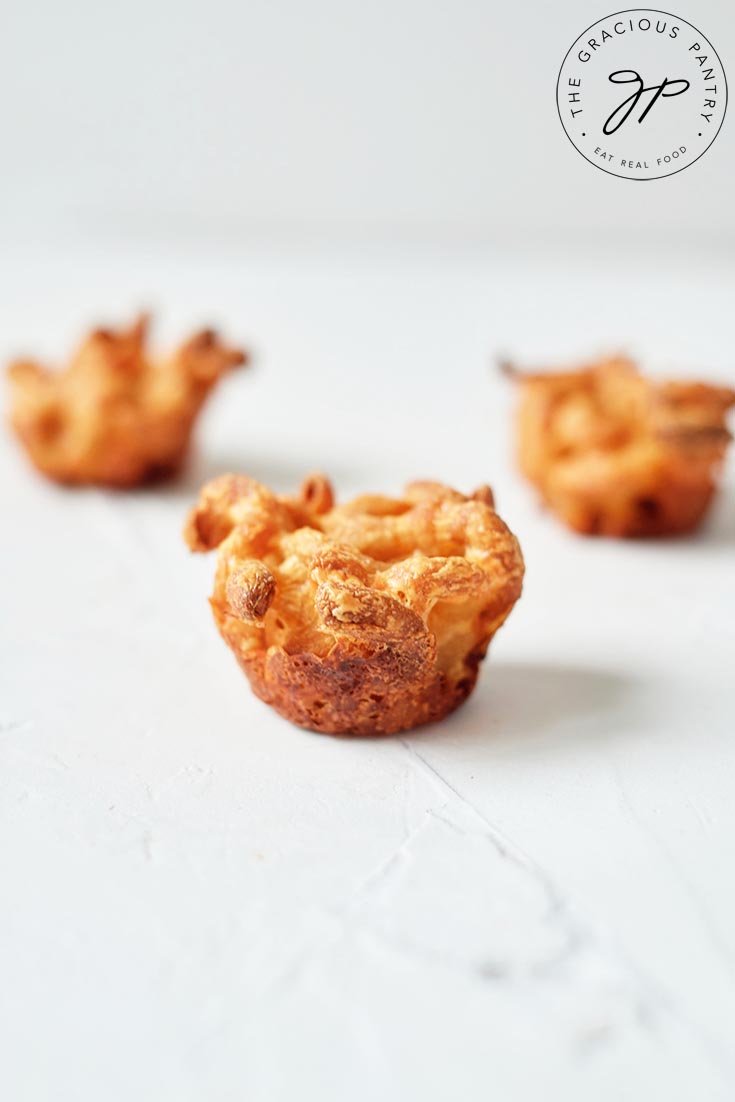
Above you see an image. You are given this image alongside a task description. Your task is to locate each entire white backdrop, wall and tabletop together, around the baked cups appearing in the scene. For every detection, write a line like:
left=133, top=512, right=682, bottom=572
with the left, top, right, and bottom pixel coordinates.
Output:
left=0, top=0, right=735, bottom=1102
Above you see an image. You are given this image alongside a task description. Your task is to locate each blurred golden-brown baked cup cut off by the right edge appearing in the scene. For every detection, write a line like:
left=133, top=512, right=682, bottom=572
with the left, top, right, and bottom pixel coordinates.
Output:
left=510, top=358, right=735, bottom=537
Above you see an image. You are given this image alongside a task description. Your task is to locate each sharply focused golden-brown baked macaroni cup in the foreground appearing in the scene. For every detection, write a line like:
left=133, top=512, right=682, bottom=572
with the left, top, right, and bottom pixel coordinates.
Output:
left=184, top=475, right=523, bottom=735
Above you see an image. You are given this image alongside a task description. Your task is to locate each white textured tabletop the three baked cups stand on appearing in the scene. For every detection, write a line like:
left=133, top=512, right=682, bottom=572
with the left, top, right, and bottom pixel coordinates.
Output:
left=0, top=245, right=735, bottom=1102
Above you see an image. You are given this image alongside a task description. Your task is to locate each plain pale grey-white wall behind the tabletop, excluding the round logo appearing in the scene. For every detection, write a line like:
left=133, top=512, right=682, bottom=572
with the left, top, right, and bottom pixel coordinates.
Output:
left=0, top=0, right=735, bottom=248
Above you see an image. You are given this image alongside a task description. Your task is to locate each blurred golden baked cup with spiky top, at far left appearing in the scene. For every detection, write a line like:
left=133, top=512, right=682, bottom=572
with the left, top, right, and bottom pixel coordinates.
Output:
left=9, top=317, right=246, bottom=487
